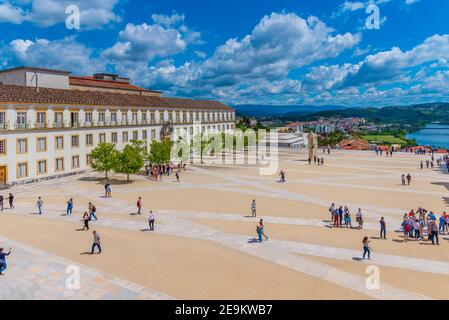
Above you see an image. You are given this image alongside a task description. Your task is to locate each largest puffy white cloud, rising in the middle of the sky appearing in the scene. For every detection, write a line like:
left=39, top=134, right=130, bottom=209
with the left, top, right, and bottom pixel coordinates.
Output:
left=138, top=13, right=360, bottom=94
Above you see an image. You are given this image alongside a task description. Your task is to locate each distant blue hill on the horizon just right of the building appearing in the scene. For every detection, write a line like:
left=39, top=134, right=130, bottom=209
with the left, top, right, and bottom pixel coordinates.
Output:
left=233, top=104, right=346, bottom=118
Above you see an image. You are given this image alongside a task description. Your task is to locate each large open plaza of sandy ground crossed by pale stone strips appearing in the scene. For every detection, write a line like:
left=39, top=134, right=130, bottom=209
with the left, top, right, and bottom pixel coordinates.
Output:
left=0, top=151, right=449, bottom=299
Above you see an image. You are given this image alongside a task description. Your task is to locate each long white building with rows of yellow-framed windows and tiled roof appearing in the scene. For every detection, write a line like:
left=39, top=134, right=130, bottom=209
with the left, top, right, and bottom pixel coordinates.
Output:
left=0, top=67, right=235, bottom=187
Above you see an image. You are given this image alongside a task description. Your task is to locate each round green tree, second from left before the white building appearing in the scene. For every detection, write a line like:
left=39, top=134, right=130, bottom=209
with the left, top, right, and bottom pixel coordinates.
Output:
left=114, top=144, right=145, bottom=182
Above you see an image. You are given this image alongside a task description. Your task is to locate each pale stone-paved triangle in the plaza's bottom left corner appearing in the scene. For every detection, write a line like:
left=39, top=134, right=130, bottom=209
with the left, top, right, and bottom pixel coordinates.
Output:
left=0, top=237, right=171, bottom=300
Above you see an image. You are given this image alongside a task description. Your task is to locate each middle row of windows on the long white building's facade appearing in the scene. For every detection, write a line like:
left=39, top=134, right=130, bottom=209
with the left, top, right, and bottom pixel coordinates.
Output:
left=0, top=129, right=156, bottom=154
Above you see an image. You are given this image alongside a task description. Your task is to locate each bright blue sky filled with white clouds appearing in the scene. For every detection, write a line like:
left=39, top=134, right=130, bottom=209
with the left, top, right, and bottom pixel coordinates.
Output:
left=0, top=0, right=449, bottom=107
